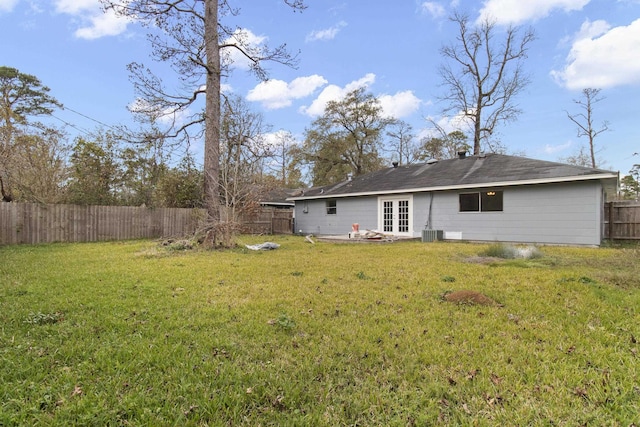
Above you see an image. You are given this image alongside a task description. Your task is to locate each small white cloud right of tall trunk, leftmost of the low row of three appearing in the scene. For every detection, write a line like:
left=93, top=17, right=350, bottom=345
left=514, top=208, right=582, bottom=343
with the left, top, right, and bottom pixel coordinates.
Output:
left=247, top=74, right=327, bottom=110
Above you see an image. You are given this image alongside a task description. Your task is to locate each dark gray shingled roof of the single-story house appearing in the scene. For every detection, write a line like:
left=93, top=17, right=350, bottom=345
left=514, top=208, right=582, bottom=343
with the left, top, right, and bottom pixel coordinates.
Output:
left=289, top=154, right=618, bottom=200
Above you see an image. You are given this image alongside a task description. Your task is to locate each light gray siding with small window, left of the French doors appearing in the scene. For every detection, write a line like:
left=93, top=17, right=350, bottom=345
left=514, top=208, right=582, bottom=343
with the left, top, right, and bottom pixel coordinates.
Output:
left=295, top=197, right=378, bottom=235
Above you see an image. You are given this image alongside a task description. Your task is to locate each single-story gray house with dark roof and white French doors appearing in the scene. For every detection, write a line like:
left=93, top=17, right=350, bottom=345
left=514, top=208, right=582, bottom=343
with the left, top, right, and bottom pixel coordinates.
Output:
left=288, top=153, right=619, bottom=245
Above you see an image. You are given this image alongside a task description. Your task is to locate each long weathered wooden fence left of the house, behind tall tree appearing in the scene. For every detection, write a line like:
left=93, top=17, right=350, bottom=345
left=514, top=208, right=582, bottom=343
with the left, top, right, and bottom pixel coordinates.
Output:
left=0, top=203, right=293, bottom=245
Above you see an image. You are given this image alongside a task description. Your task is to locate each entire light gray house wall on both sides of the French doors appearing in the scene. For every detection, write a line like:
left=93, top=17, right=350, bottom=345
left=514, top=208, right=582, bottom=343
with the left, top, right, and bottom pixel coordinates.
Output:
left=295, top=181, right=603, bottom=245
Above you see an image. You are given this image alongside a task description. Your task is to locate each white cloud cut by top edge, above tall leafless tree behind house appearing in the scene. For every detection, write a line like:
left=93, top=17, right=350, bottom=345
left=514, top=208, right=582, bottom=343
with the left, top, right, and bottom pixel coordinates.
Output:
left=478, top=0, right=590, bottom=24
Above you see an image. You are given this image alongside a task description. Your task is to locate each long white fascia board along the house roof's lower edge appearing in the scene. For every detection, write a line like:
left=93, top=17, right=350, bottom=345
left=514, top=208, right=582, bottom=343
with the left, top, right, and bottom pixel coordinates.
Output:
left=287, top=173, right=618, bottom=202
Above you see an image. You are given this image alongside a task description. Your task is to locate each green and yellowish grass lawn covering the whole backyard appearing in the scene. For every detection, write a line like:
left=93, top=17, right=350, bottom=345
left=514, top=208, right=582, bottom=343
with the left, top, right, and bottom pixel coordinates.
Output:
left=0, top=236, right=640, bottom=426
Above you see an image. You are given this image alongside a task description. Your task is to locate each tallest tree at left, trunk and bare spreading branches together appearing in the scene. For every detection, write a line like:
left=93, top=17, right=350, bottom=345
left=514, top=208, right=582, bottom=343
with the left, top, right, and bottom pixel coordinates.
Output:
left=100, top=0, right=305, bottom=244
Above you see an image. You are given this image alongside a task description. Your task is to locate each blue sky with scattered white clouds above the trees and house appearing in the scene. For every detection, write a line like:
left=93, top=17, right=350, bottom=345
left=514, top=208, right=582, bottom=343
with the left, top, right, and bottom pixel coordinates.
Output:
left=0, top=0, right=640, bottom=181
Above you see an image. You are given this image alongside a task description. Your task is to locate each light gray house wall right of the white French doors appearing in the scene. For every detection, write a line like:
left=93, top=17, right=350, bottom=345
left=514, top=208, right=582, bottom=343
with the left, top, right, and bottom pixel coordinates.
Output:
left=414, top=182, right=603, bottom=245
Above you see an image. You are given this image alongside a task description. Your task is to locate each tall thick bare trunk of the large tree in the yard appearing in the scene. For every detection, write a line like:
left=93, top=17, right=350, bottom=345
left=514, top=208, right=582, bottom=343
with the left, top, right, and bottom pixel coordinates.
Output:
left=204, top=0, right=220, bottom=244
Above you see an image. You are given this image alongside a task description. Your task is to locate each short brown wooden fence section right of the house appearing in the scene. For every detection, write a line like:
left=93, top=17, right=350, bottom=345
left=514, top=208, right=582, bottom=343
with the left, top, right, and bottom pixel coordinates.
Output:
left=604, top=201, right=640, bottom=240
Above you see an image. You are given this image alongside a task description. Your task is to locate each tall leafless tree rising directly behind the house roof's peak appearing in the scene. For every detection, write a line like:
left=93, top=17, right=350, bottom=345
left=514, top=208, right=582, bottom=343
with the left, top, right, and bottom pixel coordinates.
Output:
left=440, top=12, right=535, bottom=155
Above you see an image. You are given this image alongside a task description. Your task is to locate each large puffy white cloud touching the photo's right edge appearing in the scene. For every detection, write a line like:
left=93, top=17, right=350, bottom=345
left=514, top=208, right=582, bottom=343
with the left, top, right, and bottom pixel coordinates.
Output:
left=551, top=19, right=640, bottom=89
